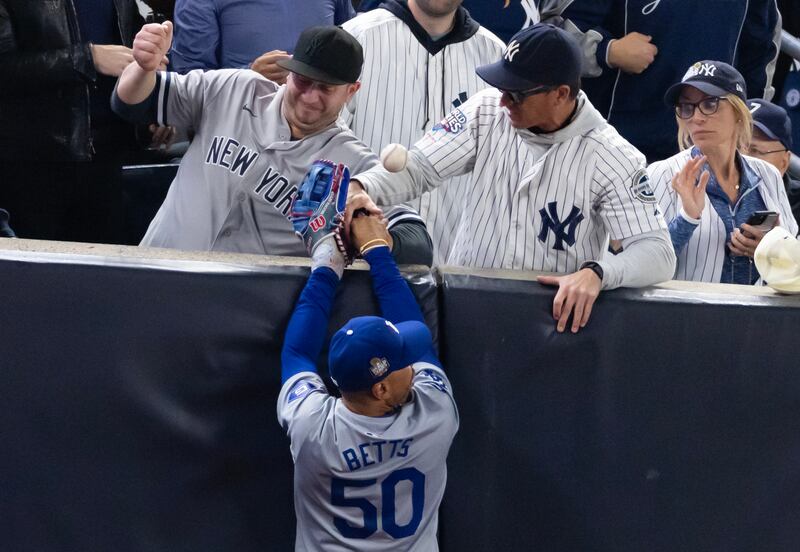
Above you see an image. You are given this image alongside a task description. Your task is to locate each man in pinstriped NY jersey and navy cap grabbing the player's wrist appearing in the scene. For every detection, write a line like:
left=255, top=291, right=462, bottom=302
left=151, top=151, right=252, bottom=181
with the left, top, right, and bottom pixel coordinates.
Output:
left=348, top=24, right=675, bottom=332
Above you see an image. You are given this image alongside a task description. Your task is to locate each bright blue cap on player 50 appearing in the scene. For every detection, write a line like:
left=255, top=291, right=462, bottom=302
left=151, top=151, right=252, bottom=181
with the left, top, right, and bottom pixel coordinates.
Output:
left=328, top=316, right=433, bottom=391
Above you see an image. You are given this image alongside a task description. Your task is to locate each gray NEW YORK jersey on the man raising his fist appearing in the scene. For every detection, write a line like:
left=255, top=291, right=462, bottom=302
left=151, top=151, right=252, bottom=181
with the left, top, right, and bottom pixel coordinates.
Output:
left=142, top=70, right=380, bottom=256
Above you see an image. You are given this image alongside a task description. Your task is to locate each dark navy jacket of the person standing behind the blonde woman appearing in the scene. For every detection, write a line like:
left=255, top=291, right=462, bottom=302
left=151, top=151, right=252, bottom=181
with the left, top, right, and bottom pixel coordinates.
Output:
left=563, top=0, right=778, bottom=162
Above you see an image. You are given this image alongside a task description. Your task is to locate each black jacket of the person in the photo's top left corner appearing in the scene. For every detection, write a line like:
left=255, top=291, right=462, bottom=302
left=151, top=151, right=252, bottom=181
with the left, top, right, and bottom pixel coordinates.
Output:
left=0, top=0, right=141, bottom=161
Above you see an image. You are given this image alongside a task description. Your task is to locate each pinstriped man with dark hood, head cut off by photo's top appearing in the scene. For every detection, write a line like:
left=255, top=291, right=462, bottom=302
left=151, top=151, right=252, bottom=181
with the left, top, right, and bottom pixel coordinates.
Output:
left=342, top=0, right=505, bottom=264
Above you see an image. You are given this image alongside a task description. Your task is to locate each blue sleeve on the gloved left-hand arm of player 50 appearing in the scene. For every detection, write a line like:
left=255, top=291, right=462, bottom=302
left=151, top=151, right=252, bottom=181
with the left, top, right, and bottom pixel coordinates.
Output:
left=281, top=267, right=339, bottom=384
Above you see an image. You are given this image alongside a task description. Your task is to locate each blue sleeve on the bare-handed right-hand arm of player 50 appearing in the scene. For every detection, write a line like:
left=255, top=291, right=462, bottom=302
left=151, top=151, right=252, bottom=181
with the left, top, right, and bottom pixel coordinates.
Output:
left=364, top=247, right=442, bottom=368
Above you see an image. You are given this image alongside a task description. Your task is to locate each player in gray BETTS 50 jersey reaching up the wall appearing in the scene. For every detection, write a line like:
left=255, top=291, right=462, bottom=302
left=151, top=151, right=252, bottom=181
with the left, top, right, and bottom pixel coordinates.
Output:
left=277, top=212, right=458, bottom=552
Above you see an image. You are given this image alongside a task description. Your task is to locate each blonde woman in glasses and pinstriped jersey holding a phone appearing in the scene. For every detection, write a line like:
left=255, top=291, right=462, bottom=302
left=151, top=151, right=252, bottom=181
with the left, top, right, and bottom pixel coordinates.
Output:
left=647, top=61, right=797, bottom=284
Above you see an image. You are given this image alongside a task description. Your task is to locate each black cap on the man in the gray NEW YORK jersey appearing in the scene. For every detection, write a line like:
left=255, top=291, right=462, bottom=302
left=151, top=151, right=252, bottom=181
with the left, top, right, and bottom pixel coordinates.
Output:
left=278, top=25, right=364, bottom=84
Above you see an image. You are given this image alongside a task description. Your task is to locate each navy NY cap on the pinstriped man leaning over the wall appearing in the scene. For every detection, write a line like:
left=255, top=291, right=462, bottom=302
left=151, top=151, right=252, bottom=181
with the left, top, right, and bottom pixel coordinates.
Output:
left=475, top=23, right=583, bottom=92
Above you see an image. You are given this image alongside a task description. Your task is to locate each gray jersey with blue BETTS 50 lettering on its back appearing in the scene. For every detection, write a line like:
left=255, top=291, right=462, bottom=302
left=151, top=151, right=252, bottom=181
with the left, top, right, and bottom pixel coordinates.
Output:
left=278, top=363, right=458, bottom=552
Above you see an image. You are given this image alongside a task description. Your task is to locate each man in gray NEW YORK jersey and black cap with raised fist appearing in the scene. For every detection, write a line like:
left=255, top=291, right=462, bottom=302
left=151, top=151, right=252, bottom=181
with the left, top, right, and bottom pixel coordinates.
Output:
left=112, top=22, right=432, bottom=264
